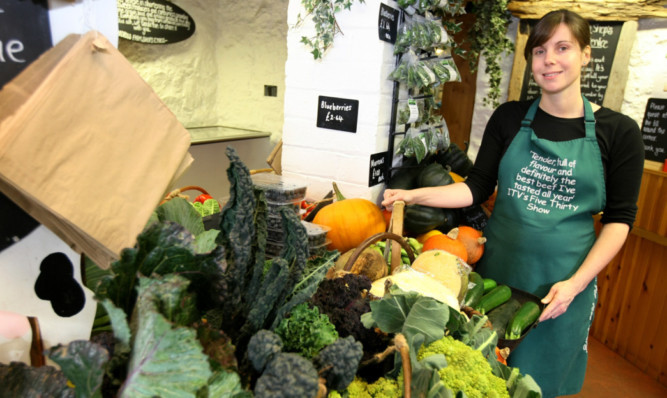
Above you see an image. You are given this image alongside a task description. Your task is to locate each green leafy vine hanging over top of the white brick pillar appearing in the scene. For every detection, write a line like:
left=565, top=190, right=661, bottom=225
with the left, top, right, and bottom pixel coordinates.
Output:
left=296, top=0, right=364, bottom=59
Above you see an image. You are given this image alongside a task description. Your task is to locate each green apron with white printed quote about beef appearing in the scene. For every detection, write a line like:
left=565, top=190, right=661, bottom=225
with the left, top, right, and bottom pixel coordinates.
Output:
left=477, top=98, right=606, bottom=397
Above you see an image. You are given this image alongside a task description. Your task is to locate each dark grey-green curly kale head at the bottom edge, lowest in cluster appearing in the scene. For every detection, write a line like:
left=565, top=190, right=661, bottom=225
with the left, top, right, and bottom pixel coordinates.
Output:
left=254, top=352, right=319, bottom=398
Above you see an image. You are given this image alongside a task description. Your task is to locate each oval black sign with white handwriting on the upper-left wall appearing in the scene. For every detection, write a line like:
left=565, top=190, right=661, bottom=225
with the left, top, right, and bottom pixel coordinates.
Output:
left=118, top=0, right=195, bottom=44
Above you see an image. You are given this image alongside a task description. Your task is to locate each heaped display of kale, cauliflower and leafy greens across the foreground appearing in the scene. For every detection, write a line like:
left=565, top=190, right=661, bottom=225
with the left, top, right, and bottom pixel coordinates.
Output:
left=0, top=148, right=540, bottom=398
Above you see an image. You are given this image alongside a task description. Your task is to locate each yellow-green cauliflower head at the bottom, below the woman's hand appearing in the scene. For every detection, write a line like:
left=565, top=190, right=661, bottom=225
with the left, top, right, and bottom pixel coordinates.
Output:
left=417, top=336, right=510, bottom=398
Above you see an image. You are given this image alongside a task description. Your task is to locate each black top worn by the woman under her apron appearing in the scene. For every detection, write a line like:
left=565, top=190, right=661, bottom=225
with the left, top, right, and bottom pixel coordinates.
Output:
left=465, top=100, right=644, bottom=227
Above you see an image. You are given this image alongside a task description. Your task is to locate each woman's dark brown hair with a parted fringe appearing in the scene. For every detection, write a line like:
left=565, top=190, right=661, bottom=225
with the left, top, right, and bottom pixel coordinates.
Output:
left=523, top=10, right=591, bottom=61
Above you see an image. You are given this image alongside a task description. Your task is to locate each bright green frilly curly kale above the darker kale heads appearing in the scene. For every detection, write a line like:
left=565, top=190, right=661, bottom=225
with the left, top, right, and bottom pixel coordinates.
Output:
left=275, top=303, right=338, bottom=358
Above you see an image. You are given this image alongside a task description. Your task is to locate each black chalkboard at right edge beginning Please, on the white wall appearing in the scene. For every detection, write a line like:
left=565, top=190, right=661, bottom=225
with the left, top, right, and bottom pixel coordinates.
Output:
left=642, top=98, right=667, bottom=163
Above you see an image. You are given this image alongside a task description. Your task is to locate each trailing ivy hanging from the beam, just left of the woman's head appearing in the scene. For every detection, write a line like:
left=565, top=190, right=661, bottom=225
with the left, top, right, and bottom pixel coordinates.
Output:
left=467, top=0, right=514, bottom=108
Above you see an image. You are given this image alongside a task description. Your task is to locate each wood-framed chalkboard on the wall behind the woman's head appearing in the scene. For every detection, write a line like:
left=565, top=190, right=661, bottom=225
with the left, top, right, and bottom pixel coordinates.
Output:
left=520, top=20, right=623, bottom=105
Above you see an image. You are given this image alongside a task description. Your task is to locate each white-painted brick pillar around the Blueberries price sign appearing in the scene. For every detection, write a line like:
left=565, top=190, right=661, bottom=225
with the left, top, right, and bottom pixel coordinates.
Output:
left=282, top=0, right=397, bottom=201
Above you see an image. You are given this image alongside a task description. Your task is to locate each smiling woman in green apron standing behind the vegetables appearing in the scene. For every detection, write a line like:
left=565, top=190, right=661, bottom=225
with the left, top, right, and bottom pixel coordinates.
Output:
left=382, top=10, right=644, bottom=397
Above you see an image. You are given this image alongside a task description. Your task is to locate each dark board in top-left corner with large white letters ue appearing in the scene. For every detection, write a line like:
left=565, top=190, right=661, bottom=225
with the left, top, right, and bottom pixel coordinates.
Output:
left=0, top=0, right=52, bottom=88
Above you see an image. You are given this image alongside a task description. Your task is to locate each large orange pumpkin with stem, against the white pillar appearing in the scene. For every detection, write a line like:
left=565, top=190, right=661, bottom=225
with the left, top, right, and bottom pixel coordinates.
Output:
left=313, top=183, right=387, bottom=253
